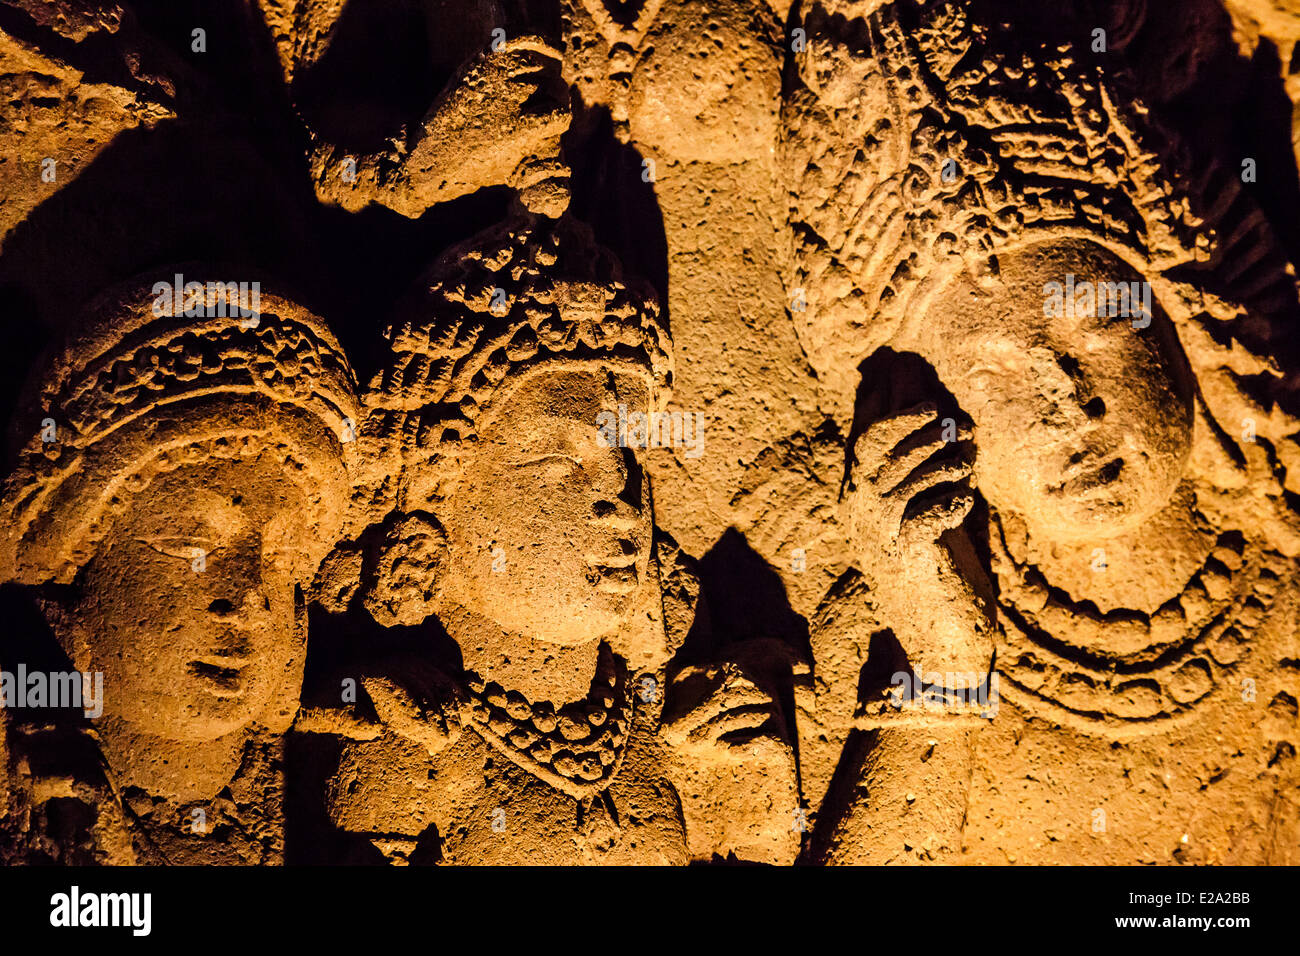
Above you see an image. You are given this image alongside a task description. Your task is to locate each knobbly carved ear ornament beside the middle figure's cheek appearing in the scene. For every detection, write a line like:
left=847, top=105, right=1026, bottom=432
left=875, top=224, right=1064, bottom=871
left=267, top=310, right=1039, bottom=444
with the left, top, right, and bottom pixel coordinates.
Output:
left=363, top=512, right=447, bottom=627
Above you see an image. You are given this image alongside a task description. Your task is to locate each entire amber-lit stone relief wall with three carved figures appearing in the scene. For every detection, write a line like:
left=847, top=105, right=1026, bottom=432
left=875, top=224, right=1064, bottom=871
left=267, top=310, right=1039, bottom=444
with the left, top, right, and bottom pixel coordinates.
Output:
left=0, top=0, right=1300, bottom=865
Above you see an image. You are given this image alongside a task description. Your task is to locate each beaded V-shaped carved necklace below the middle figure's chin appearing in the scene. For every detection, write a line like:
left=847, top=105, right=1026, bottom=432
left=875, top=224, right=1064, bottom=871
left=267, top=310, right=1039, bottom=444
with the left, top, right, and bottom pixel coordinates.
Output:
left=465, top=646, right=633, bottom=800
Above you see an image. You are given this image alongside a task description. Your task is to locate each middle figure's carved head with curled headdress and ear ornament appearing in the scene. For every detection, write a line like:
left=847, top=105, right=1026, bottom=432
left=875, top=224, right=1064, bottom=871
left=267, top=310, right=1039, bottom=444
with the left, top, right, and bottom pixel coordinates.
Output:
left=364, top=221, right=671, bottom=644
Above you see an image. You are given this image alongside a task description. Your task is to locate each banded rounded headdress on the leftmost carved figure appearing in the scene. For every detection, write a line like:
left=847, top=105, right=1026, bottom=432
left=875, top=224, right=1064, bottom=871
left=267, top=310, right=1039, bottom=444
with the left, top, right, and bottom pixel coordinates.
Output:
left=0, top=267, right=359, bottom=583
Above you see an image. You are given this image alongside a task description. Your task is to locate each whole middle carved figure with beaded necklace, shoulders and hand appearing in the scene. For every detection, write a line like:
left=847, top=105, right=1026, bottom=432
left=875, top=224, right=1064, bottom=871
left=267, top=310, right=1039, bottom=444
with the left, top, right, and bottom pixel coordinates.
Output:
left=297, top=219, right=798, bottom=864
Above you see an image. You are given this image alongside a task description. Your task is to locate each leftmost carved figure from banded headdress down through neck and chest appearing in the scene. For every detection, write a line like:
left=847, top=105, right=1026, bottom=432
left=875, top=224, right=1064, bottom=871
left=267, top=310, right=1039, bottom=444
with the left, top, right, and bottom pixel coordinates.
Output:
left=4, top=273, right=359, bottom=862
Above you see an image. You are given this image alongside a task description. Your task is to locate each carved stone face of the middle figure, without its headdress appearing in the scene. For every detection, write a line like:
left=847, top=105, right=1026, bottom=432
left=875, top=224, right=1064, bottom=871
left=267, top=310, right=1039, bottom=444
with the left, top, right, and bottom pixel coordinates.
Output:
left=439, top=360, right=660, bottom=645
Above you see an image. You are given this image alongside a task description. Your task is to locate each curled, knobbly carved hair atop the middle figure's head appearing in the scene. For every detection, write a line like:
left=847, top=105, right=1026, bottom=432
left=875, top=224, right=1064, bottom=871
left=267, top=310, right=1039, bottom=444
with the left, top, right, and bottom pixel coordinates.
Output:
left=363, top=217, right=672, bottom=509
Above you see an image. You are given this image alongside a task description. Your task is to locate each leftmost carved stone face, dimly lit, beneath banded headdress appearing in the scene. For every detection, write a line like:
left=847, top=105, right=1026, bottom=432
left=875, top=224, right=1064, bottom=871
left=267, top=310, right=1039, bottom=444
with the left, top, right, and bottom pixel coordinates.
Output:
left=73, top=451, right=311, bottom=740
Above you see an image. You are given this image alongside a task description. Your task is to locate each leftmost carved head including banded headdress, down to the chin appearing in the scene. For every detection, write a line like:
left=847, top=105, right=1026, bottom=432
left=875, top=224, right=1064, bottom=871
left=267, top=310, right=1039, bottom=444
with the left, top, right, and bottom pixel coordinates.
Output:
left=4, top=274, right=358, bottom=740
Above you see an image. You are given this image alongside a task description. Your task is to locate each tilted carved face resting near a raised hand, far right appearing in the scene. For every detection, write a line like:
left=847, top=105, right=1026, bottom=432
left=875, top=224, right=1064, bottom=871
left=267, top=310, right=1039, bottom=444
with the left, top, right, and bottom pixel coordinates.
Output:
left=924, top=241, right=1192, bottom=540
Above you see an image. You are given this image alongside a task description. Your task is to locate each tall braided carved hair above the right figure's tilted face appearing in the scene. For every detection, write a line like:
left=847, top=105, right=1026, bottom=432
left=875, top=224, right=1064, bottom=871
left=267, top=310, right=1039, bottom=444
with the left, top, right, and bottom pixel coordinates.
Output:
left=781, top=0, right=1300, bottom=504
